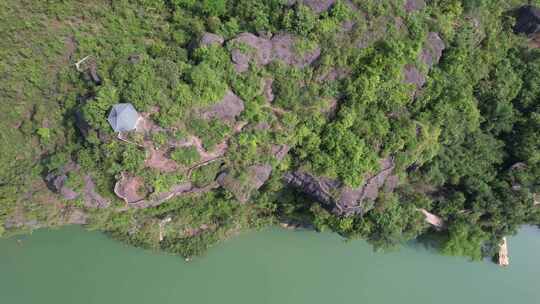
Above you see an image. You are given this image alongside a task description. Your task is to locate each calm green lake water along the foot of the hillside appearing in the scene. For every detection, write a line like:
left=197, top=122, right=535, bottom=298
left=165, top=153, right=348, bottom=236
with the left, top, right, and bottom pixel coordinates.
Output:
left=0, top=227, right=540, bottom=304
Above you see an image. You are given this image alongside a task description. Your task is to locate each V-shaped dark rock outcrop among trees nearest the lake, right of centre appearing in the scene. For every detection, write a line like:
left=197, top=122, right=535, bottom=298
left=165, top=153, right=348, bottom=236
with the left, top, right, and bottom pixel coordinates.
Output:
left=284, top=158, right=395, bottom=216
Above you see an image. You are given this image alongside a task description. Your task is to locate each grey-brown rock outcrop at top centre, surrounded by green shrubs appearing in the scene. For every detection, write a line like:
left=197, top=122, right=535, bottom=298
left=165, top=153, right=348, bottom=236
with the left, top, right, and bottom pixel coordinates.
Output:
left=228, top=33, right=321, bottom=73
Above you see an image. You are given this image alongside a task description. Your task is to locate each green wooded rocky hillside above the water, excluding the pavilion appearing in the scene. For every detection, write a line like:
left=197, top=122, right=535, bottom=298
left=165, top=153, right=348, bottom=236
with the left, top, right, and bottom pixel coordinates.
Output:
left=0, top=0, right=540, bottom=259
